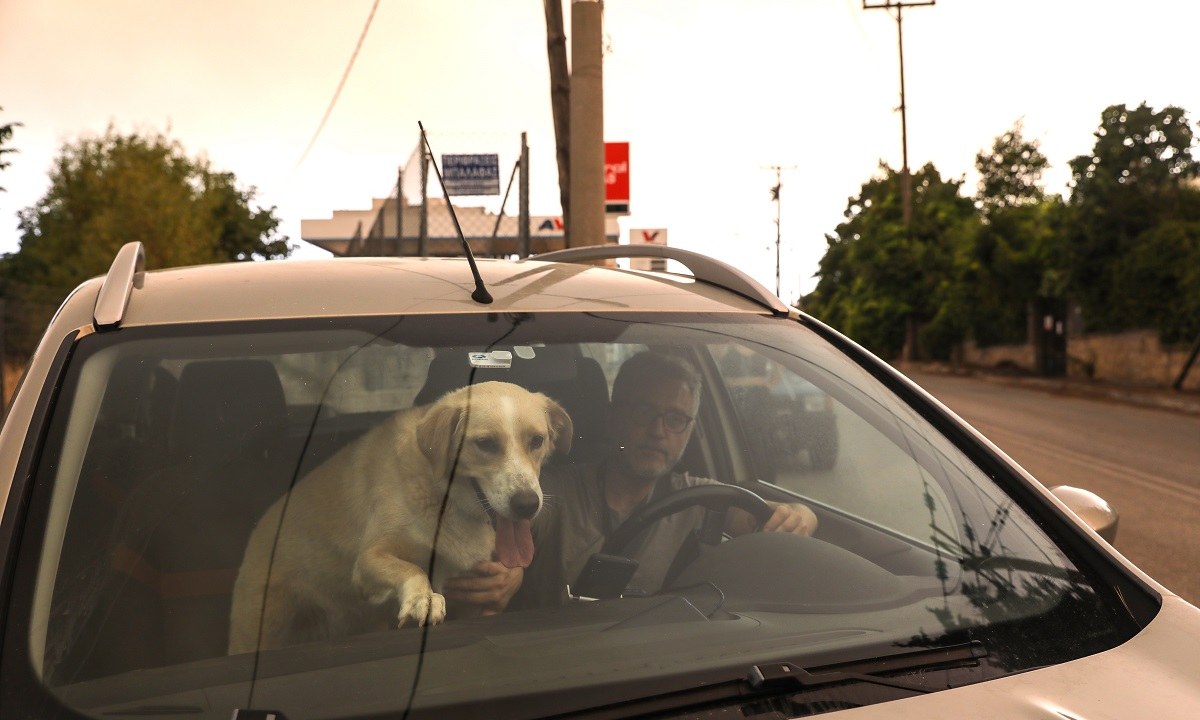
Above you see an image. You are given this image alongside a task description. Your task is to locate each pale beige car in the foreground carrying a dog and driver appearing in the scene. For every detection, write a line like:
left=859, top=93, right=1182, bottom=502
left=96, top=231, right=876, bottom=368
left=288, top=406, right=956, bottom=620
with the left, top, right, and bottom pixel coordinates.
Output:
left=0, top=245, right=1200, bottom=720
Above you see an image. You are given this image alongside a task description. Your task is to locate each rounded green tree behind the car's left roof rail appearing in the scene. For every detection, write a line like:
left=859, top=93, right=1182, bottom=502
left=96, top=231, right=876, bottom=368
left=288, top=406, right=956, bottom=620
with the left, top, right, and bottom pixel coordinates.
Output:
left=0, top=128, right=292, bottom=355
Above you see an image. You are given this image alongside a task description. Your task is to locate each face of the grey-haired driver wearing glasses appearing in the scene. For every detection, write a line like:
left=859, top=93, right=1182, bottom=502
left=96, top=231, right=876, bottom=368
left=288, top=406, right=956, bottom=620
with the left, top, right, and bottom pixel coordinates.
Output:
left=608, top=380, right=697, bottom=482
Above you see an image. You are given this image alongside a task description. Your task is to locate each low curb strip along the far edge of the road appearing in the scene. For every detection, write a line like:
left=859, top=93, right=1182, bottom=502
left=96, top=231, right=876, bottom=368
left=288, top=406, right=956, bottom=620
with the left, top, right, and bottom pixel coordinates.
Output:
left=896, top=362, right=1200, bottom=416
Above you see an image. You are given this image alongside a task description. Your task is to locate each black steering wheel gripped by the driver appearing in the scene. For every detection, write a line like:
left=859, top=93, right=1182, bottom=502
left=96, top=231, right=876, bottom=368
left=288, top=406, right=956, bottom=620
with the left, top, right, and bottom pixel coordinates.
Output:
left=600, top=482, right=774, bottom=556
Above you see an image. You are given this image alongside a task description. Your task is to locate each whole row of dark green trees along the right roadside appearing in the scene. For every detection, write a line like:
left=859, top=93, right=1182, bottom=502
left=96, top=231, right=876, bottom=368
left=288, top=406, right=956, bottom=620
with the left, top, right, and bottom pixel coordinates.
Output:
left=805, top=104, right=1200, bottom=358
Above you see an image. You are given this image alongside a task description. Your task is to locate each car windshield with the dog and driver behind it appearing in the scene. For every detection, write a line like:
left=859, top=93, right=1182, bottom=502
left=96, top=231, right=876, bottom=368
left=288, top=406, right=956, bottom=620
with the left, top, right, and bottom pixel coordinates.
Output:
left=18, top=313, right=1136, bottom=720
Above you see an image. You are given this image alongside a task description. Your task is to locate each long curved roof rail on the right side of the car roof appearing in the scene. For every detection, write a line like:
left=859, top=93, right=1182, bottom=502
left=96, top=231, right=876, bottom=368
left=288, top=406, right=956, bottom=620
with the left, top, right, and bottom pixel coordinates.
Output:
left=529, top=245, right=791, bottom=314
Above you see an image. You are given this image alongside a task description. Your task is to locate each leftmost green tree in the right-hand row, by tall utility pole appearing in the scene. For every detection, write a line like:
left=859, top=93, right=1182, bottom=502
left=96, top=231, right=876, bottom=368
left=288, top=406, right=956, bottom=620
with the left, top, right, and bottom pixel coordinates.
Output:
left=805, top=164, right=978, bottom=358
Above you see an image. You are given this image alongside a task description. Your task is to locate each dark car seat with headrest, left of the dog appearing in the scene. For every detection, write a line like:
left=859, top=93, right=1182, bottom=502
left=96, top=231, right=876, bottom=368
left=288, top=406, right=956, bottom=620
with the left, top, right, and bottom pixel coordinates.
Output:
left=55, top=359, right=300, bottom=680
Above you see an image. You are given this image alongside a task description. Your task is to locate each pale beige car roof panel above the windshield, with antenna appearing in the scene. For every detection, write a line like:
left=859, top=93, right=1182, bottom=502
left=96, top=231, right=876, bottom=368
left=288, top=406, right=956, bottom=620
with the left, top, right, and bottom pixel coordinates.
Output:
left=65, top=244, right=787, bottom=326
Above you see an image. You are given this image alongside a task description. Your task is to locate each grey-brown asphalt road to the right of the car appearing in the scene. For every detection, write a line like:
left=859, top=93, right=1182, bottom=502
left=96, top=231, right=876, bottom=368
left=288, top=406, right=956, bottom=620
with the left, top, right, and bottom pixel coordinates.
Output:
left=908, top=372, right=1200, bottom=604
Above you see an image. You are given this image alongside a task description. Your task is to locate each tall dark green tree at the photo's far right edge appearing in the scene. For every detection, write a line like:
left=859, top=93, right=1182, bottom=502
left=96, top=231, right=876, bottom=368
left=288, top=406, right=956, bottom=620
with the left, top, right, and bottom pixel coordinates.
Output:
left=1069, top=103, right=1200, bottom=330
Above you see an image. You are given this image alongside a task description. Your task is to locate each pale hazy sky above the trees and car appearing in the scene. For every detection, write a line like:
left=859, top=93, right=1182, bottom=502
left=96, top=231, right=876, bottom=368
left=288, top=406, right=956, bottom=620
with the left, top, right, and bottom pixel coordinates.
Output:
left=0, top=0, right=1200, bottom=300
